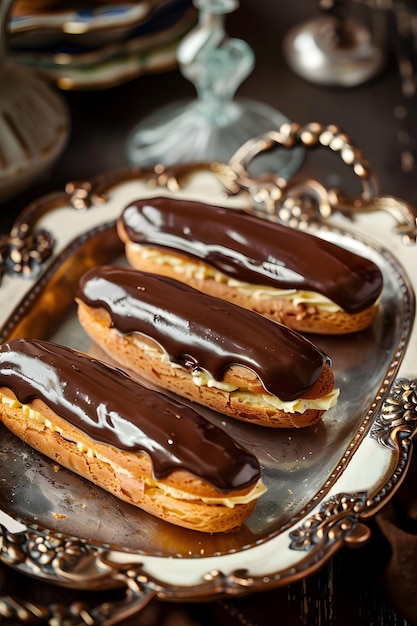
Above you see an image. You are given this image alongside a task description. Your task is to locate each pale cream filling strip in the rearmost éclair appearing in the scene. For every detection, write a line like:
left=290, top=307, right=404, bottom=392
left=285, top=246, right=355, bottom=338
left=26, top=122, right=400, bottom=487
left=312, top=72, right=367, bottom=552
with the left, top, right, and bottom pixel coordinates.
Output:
left=129, top=243, right=343, bottom=313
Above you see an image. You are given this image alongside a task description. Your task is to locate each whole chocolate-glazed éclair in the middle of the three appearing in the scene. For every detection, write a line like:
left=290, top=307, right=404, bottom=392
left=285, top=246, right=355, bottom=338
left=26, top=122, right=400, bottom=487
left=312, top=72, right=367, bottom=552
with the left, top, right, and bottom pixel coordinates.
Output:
left=76, top=266, right=338, bottom=428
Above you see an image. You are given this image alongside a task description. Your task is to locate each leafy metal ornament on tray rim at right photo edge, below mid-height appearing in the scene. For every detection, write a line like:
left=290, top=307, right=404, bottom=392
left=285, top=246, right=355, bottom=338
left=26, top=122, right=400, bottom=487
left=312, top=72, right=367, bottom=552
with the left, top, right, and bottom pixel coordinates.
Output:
left=371, top=378, right=417, bottom=449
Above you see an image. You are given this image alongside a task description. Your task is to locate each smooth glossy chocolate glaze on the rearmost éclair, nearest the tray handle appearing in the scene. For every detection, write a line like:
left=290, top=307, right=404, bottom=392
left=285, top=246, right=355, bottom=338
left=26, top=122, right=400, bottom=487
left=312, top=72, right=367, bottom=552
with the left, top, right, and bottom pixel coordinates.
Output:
left=120, top=197, right=382, bottom=313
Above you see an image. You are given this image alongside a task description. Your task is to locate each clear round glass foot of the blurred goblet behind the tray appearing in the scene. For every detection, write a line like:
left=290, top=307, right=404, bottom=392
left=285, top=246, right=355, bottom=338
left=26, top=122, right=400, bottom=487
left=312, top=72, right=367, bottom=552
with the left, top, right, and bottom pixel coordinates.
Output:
left=127, top=98, right=304, bottom=178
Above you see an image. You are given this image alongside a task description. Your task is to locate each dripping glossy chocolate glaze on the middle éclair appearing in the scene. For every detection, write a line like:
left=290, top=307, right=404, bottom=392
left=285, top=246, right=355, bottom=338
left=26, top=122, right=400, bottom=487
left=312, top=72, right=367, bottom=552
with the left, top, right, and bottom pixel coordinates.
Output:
left=77, top=266, right=329, bottom=400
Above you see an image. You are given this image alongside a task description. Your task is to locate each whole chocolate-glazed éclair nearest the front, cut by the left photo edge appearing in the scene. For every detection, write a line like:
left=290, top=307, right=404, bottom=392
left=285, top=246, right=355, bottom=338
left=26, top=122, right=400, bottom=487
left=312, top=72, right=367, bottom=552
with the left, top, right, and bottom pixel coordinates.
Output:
left=0, top=339, right=265, bottom=533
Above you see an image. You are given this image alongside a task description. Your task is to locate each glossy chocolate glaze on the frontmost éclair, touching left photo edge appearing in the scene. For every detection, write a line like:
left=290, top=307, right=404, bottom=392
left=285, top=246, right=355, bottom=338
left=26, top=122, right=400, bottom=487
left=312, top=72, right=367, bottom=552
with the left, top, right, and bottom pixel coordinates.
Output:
left=0, top=339, right=259, bottom=493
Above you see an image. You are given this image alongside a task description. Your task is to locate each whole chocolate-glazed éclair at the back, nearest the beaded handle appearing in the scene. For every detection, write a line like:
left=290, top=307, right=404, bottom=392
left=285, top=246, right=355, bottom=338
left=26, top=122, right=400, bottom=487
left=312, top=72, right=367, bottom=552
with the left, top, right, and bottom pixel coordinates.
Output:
left=118, top=197, right=383, bottom=334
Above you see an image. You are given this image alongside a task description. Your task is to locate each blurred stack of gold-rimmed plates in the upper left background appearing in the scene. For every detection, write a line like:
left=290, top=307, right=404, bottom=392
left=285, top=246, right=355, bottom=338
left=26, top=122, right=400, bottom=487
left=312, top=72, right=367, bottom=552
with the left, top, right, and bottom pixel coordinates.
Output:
left=10, top=0, right=197, bottom=89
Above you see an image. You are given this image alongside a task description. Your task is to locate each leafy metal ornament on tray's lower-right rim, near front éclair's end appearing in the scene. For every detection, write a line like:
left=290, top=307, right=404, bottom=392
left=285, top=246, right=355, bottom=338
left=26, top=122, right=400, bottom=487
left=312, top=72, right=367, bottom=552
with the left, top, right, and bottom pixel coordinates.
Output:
left=290, top=492, right=367, bottom=551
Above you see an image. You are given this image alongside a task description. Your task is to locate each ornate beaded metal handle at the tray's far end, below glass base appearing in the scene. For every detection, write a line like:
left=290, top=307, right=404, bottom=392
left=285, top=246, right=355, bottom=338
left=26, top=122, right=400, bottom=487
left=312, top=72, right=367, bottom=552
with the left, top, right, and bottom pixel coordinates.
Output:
left=229, top=122, right=417, bottom=245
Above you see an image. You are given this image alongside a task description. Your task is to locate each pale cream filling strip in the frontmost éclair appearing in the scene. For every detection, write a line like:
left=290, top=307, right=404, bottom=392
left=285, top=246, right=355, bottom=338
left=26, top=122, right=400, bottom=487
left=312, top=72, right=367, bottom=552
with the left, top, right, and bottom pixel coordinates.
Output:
left=0, top=393, right=267, bottom=508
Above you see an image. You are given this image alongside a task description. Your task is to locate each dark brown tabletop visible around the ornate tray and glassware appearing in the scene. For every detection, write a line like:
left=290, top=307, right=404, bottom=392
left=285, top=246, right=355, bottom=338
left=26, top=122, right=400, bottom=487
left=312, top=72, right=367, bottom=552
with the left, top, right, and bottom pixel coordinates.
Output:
left=0, top=0, right=417, bottom=626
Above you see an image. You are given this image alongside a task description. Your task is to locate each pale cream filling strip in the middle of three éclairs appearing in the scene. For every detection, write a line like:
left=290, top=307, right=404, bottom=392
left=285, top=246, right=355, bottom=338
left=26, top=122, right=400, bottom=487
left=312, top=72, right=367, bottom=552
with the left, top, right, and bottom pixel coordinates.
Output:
left=130, top=334, right=340, bottom=413
